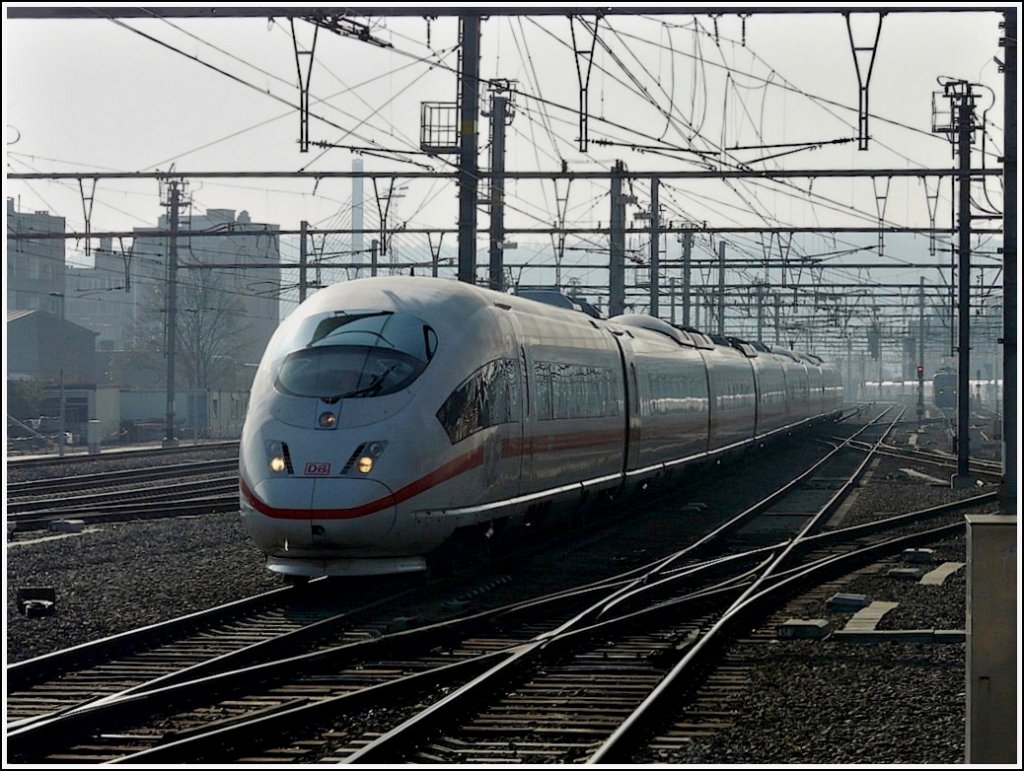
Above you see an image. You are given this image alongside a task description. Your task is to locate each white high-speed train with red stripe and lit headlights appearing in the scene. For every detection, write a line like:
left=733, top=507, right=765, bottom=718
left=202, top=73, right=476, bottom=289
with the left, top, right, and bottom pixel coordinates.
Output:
left=240, top=277, right=842, bottom=576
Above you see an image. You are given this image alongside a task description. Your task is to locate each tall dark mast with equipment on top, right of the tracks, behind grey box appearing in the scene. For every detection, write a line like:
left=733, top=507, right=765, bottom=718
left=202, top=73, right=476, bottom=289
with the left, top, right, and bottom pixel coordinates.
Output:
left=946, top=82, right=974, bottom=488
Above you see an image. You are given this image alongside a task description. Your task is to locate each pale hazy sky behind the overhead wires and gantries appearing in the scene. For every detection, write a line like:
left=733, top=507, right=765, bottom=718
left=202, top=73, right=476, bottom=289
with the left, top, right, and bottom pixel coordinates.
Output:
left=3, top=3, right=1012, bottom=296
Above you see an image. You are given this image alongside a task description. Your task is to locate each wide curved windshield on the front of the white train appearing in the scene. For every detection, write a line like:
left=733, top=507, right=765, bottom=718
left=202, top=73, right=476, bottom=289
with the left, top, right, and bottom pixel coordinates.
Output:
left=274, top=311, right=437, bottom=400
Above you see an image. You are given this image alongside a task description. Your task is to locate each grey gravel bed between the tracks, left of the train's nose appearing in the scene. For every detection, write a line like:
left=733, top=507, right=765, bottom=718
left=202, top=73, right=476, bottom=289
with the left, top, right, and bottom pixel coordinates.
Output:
left=6, top=512, right=282, bottom=663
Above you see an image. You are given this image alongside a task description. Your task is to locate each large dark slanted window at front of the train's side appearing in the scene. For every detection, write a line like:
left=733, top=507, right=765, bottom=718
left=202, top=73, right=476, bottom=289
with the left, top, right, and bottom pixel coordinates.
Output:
left=437, top=358, right=522, bottom=444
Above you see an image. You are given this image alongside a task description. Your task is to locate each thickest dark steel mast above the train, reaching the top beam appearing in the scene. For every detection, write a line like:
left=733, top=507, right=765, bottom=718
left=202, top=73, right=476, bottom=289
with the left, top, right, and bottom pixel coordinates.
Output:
left=459, top=12, right=480, bottom=284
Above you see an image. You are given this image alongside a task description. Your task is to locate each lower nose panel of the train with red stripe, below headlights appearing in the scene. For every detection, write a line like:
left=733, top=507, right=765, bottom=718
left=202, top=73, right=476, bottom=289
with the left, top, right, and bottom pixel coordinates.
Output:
left=243, top=478, right=395, bottom=557
